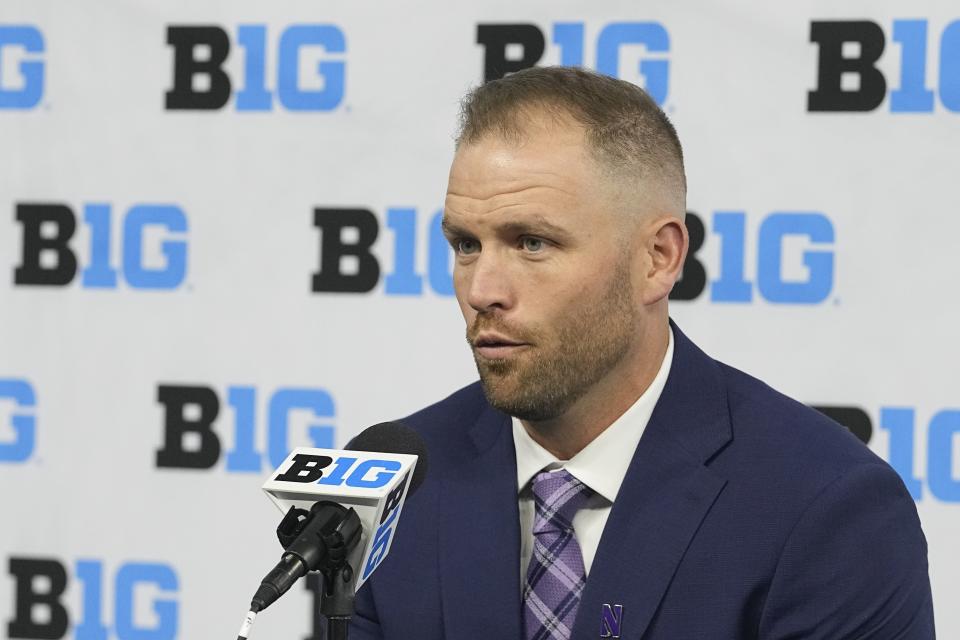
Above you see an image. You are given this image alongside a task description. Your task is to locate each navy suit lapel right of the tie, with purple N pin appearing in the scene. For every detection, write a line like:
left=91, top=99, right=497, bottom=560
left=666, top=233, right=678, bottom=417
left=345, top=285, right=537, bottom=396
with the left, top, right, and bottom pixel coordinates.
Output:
left=573, top=326, right=731, bottom=640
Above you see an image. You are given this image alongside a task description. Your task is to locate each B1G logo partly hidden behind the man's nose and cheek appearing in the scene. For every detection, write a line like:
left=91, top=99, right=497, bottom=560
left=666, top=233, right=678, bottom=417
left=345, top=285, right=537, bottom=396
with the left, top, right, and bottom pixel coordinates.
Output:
left=311, top=207, right=453, bottom=296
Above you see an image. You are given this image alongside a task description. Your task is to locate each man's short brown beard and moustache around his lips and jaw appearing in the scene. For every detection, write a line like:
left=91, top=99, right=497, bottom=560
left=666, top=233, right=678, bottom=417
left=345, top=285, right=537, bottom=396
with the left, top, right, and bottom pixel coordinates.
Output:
left=467, top=260, right=637, bottom=422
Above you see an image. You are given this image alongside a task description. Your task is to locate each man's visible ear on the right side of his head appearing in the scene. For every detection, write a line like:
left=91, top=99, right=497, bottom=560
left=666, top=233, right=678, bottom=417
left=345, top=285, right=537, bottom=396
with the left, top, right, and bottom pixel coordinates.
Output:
left=642, top=216, right=690, bottom=305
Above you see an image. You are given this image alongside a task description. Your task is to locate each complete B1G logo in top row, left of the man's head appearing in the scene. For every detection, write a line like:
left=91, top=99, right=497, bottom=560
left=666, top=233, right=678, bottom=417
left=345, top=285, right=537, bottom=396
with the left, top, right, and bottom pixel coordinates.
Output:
left=166, top=24, right=347, bottom=111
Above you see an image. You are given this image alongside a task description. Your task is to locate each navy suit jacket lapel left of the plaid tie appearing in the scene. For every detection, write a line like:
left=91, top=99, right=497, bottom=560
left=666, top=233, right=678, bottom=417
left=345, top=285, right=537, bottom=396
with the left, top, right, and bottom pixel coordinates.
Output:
left=438, top=407, right=521, bottom=640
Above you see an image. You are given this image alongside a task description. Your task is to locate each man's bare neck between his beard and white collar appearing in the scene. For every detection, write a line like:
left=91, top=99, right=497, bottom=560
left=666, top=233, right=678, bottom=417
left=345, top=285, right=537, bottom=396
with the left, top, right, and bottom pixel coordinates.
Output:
left=520, top=324, right=670, bottom=460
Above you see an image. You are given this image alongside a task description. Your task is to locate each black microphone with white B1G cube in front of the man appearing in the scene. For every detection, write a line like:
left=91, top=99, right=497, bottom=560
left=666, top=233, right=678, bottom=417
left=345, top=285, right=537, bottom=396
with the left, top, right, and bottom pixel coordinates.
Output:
left=238, top=422, right=427, bottom=640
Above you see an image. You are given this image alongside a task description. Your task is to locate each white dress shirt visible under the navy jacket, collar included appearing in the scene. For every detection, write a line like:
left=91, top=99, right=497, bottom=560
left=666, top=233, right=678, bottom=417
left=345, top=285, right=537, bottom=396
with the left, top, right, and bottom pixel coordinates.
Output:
left=513, top=329, right=673, bottom=590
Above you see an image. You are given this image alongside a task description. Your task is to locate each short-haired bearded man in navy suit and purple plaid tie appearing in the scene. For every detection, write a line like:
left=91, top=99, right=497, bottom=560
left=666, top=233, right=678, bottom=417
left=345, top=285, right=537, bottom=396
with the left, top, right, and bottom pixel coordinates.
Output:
left=351, top=68, right=934, bottom=640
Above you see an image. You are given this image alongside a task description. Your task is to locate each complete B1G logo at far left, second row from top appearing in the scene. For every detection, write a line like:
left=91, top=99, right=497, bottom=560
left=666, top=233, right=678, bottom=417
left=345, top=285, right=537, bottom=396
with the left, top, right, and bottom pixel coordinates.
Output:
left=13, top=203, right=187, bottom=289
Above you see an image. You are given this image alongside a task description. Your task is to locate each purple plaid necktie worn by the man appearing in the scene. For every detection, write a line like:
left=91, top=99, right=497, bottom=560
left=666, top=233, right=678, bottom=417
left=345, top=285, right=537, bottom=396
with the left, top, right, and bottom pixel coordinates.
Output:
left=523, top=469, right=593, bottom=640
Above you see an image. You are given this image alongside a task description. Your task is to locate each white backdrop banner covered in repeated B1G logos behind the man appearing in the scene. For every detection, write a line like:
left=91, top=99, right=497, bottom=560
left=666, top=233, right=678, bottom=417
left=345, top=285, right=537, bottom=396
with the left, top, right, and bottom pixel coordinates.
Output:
left=0, top=0, right=960, bottom=640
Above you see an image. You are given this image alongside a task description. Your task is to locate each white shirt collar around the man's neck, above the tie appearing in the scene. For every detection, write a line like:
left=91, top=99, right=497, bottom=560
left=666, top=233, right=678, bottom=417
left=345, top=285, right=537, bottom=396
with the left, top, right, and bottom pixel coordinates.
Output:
left=513, top=328, right=673, bottom=502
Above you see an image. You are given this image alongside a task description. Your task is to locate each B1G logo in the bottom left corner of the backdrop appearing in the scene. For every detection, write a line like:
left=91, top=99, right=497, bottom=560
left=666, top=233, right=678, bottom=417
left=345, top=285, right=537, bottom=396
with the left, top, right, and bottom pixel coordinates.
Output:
left=7, top=557, right=180, bottom=640
